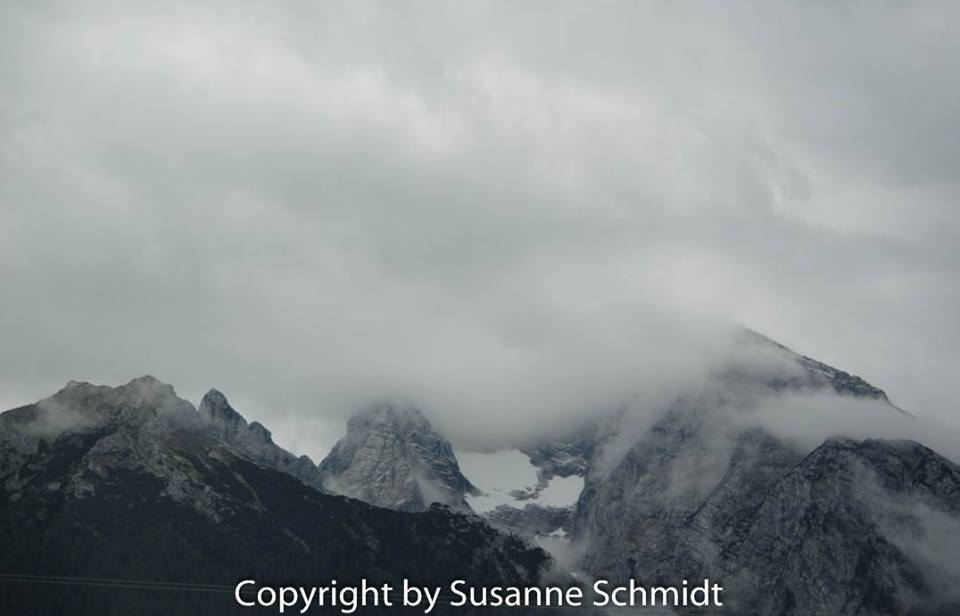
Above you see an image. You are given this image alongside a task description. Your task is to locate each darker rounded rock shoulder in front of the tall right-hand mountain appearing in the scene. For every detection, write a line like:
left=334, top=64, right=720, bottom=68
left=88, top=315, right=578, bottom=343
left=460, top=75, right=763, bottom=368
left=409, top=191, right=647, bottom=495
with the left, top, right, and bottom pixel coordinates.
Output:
left=714, top=439, right=960, bottom=614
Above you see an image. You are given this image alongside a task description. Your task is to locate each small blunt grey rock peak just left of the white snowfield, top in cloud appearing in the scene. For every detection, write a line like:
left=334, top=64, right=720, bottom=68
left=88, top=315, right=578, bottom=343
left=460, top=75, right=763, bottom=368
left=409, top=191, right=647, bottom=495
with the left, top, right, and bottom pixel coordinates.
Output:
left=320, top=406, right=476, bottom=511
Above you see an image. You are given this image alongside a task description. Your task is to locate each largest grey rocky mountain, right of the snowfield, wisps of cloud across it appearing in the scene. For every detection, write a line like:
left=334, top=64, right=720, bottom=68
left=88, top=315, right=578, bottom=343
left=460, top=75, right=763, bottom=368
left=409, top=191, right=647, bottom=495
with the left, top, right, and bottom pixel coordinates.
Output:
left=568, top=334, right=960, bottom=616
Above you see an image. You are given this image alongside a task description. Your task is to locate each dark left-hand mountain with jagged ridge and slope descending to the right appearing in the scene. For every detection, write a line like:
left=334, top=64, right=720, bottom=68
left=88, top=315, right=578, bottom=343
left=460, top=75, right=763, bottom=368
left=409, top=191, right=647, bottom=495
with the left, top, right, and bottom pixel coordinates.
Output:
left=0, top=377, right=549, bottom=616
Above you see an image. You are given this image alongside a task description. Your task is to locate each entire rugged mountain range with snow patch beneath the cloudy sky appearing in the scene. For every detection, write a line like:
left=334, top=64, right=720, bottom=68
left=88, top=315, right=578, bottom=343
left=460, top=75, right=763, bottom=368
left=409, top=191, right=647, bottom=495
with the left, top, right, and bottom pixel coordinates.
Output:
left=0, top=332, right=960, bottom=616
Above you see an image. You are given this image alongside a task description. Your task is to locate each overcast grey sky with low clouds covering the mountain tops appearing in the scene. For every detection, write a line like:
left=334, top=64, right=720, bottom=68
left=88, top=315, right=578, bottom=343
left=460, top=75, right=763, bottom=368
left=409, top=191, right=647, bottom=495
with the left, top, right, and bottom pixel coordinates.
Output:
left=0, top=0, right=960, bottom=457
